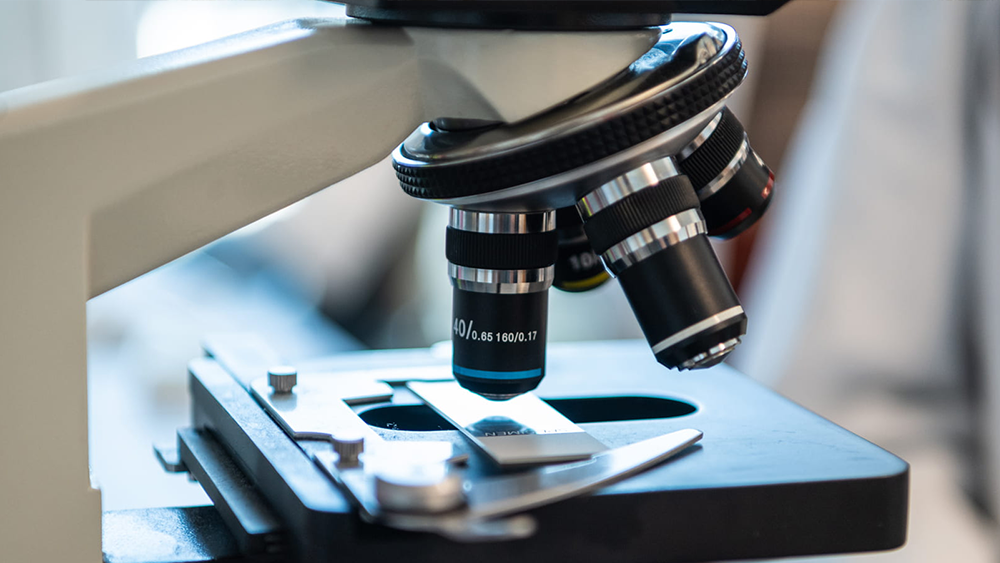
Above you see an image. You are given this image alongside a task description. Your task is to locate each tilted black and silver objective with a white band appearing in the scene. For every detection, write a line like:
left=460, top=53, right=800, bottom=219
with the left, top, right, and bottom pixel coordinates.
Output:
left=577, top=157, right=746, bottom=369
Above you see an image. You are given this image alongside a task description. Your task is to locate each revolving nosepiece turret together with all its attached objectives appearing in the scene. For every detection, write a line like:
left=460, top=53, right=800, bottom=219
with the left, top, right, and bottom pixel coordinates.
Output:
left=393, top=22, right=774, bottom=399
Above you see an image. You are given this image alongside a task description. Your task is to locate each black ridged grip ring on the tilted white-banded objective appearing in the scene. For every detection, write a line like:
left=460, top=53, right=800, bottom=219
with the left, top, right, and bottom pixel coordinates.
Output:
left=583, top=176, right=698, bottom=254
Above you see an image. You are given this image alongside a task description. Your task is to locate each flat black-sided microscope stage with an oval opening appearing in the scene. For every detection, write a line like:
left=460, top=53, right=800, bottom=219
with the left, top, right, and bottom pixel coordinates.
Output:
left=106, top=342, right=909, bottom=563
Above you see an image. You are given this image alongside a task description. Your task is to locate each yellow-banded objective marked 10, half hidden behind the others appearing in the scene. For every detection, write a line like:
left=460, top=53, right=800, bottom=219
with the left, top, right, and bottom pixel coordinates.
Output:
left=552, top=207, right=611, bottom=293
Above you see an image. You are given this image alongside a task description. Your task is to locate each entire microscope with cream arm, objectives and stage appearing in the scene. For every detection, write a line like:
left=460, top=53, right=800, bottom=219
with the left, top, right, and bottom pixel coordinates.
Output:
left=0, top=0, right=908, bottom=563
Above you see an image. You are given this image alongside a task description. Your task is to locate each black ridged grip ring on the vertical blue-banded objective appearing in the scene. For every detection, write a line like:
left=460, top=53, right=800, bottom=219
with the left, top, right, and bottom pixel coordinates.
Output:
left=445, top=227, right=559, bottom=270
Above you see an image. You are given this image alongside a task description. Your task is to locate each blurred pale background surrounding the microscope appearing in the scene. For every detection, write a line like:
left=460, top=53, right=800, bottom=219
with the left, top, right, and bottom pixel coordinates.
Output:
left=0, top=0, right=1000, bottom=562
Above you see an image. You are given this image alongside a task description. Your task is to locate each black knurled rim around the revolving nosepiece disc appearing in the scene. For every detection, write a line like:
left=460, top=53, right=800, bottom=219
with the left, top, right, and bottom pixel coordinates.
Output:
left=392, top=43, right=747, bottom=199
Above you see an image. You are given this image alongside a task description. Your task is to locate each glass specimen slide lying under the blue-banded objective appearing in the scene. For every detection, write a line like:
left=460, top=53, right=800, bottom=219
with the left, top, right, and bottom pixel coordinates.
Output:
left=407, top=381, right=607, bottom=466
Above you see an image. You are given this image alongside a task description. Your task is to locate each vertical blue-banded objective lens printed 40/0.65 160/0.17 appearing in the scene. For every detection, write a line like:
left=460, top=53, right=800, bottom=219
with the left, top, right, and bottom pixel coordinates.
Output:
left=446, top=208, right=558, bottom=400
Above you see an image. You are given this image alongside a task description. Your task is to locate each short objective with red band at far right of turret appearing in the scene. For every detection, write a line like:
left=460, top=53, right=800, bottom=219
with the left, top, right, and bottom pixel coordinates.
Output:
left=678, top=108, right=774, bottom=239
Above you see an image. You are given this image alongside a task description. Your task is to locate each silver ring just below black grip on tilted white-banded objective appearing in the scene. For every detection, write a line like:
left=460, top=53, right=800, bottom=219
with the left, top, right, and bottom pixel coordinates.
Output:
left=601, top=209, right=708, bottom=275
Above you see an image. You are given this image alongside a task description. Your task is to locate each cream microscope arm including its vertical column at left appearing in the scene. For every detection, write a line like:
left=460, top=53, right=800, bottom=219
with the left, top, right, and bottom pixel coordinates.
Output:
left=0, top=20, right=658, bottom=561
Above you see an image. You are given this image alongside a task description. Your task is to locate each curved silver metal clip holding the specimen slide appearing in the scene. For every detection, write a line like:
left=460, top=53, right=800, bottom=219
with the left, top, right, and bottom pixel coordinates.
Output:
left=317, top=429, right=702, bottom=542
